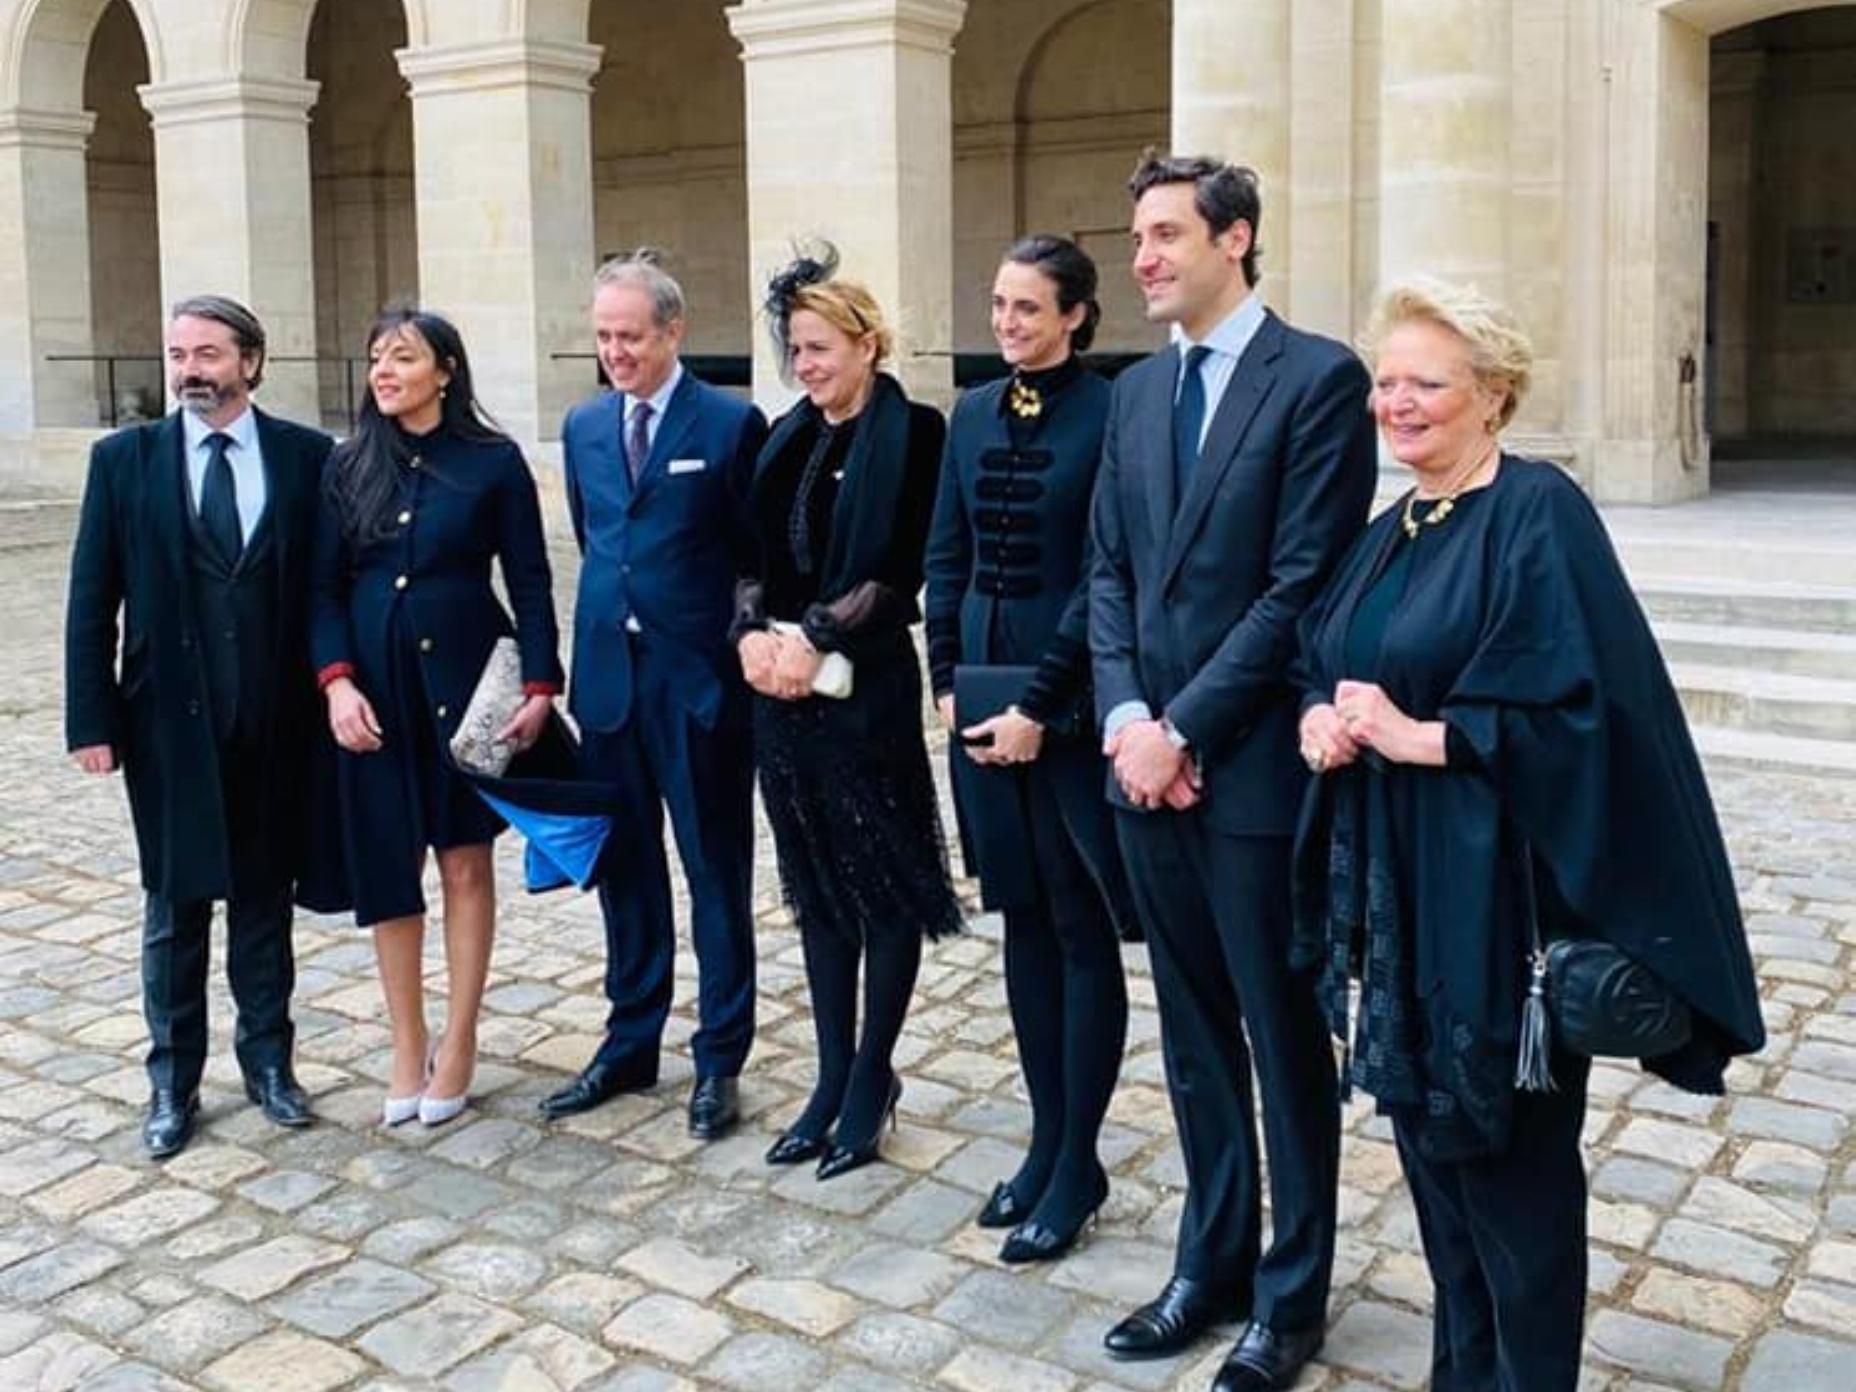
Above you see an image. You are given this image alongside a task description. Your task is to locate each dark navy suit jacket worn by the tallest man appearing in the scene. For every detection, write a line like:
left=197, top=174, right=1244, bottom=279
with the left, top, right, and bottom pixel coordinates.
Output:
left=1089, top=314, right=1377, bottom=835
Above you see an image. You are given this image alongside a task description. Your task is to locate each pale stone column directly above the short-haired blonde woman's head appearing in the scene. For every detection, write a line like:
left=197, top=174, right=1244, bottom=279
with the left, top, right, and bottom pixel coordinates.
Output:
left=1379, top=0, right=1514, bottom=299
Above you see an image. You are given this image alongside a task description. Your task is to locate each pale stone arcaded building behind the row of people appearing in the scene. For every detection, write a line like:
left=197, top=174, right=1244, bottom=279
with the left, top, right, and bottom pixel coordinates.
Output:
left=0, top=0, right=1856, bottom=503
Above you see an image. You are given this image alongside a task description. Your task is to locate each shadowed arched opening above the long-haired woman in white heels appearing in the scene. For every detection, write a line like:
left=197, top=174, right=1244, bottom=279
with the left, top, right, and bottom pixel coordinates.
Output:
left=308, top=0, right=419, bottom=431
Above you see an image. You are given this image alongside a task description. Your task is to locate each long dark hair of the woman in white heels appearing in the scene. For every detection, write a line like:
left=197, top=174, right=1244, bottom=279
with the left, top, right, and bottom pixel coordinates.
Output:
left=323, top=304, right=509, bottom=546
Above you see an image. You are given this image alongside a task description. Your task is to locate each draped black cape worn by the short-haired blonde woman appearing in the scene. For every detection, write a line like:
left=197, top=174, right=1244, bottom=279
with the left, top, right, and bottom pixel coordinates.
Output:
left=1295, top=455, right=1765, bottom=1121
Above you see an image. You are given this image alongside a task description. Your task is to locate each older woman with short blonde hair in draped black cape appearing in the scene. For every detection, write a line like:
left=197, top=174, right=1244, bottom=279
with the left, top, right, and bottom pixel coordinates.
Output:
left=1295, top=284, right=1763, bottom=1392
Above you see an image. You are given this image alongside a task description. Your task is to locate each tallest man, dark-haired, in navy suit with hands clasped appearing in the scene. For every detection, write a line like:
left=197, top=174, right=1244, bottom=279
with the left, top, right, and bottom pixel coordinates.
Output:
left=1089, top=152, right=1375, bottom=1392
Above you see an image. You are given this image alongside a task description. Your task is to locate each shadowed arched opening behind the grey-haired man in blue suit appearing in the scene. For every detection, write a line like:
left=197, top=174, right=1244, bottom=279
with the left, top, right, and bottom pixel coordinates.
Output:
left=585, top=0, right=754, bottom=386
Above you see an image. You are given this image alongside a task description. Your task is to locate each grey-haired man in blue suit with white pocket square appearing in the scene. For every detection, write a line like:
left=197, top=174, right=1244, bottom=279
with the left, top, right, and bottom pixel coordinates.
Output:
left=542, top=252, right=767, bottom=1140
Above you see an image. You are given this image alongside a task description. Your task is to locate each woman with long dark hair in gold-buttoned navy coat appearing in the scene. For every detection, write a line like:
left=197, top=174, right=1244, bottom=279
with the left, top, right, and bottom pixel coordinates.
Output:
left=310, top=310, right=562, bottom=1125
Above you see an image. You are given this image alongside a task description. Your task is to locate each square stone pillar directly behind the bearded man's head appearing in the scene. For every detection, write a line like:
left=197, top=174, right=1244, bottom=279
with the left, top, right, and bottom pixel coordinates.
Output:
left=139, top=78, right=321, bottom=423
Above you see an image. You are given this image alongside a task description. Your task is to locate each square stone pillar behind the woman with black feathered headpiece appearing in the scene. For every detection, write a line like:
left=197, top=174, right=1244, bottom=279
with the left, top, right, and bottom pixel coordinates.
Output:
left=728, top=0, right=967, bottom=406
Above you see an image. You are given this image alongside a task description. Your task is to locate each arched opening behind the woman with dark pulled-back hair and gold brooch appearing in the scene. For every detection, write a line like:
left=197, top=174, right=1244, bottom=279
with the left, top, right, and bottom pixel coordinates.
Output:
left=954, top=0, right=1171, bottom=380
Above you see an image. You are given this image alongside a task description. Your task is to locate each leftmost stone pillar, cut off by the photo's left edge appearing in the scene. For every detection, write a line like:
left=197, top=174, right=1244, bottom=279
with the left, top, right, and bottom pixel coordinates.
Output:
left=0, top=108, right=97, bottom=434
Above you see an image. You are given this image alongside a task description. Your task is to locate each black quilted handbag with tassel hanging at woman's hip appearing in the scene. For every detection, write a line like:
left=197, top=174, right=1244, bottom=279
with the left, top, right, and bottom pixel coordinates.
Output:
left=1514, top=852, right=1695, bottom=1091
